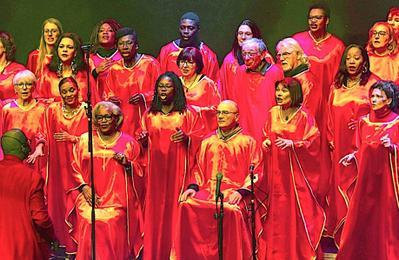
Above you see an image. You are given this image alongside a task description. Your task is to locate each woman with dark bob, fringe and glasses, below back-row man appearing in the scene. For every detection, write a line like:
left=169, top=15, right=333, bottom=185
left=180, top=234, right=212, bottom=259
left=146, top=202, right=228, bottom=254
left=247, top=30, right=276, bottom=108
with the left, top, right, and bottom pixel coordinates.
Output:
left=177, top=47, right=220, bottom=132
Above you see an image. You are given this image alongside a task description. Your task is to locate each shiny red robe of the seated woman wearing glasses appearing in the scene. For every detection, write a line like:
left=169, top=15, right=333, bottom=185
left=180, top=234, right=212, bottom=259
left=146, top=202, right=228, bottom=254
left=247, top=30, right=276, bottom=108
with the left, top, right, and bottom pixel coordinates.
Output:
left=67, top=132, right=143, bottom=260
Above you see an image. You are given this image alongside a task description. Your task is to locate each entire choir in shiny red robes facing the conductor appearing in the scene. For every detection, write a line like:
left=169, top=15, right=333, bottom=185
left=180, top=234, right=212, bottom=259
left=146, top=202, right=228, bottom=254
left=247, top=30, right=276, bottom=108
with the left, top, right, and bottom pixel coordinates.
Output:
left=0, top=4, right=399, bottom=260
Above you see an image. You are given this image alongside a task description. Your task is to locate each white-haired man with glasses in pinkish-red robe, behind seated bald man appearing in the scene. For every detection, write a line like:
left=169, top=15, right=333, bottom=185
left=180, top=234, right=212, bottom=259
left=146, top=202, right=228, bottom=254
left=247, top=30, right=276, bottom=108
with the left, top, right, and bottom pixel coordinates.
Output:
left=232, top=38, right=284, bottom=142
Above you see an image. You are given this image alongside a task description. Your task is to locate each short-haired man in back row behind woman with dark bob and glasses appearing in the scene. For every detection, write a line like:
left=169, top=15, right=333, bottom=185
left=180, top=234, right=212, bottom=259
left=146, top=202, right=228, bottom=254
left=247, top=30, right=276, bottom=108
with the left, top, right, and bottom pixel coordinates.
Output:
left=158, top=12, right=219, bottom=82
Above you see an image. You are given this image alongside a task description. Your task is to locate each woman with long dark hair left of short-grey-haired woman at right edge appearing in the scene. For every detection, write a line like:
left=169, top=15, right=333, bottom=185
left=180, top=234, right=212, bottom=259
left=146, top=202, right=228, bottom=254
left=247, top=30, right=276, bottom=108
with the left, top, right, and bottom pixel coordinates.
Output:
left=326, top=44, right=378, bottom=247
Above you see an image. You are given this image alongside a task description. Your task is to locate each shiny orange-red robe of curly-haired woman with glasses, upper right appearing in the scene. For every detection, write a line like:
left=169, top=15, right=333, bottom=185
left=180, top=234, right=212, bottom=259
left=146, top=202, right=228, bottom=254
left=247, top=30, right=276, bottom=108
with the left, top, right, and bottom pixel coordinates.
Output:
left=368, top=52, right=399, bottom=83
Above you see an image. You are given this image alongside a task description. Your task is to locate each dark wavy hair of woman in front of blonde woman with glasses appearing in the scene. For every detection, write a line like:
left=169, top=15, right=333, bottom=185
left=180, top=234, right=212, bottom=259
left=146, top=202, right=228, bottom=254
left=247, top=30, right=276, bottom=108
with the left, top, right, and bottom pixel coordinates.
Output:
left=49, top=33, right=86, bottom=72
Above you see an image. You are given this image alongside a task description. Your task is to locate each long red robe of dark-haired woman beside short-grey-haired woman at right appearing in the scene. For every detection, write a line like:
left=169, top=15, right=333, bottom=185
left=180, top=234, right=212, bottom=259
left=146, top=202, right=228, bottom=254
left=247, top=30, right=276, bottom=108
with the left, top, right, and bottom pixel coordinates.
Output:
left=326, top=74, right=378, bottom=246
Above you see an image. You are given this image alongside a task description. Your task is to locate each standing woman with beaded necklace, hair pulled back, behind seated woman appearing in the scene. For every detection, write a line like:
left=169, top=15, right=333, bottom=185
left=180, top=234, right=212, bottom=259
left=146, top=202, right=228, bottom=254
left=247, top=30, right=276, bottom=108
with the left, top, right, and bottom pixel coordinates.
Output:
left=46, top=77, right=88, bottom=253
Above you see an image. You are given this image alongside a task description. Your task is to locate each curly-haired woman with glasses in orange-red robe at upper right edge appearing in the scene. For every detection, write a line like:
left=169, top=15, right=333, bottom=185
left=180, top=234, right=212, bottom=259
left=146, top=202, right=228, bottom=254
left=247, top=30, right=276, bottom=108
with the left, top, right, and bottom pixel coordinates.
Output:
left=366, top=22, right=399, bottom=82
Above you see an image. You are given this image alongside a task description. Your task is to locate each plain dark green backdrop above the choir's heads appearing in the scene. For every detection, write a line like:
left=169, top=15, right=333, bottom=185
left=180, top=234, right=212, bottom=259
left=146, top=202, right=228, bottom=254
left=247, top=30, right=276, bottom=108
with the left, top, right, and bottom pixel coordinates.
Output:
left=0, top=0, right=399, bottom=63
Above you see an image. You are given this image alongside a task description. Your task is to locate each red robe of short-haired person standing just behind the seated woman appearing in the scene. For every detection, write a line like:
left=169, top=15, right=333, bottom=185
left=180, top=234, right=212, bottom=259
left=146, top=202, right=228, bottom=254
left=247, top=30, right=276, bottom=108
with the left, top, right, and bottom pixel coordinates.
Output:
left=104, top=54, right=160, bottom=136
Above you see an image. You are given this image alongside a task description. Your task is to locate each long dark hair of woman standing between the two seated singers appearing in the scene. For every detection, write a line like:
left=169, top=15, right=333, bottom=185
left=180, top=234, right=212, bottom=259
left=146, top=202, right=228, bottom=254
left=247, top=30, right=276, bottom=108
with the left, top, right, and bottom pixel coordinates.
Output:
left=149, top=71, right=187, bottom=114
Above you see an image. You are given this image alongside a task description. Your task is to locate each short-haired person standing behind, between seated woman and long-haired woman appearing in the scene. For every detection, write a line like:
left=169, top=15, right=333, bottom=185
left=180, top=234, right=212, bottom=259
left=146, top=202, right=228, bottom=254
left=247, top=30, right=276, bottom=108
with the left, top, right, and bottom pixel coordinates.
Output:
left=104, top=27, right=160, bottom=136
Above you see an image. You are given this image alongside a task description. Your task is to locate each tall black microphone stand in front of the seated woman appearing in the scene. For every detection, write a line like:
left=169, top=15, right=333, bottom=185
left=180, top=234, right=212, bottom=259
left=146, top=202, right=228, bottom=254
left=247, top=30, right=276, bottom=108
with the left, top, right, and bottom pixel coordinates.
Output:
left=81, top=45, right=96, bottom=260
